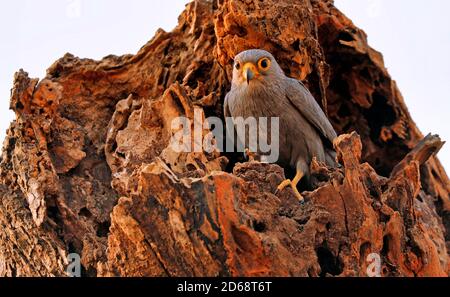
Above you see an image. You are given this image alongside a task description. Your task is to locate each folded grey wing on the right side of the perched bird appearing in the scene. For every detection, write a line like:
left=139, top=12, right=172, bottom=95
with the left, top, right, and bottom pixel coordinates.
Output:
left=286, top=78, right=337, bottom=146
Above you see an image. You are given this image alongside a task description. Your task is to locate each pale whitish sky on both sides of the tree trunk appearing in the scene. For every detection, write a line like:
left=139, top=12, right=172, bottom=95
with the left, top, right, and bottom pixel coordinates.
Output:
left=0, top=0, right=450, bottom=169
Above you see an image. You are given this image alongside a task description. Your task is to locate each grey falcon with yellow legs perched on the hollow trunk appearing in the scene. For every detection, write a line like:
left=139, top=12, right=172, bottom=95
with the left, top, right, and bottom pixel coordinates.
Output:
left=223, top=49, right=337, bottom=202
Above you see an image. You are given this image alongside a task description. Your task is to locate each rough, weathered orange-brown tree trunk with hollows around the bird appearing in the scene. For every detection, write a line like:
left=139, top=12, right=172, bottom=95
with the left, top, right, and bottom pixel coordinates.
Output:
left=0, top=0, right=450, bottom=276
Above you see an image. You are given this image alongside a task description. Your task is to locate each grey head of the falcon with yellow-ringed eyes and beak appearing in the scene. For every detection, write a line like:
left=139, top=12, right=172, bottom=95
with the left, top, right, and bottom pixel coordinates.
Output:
left=233, top=49, right=284, bottom=87
